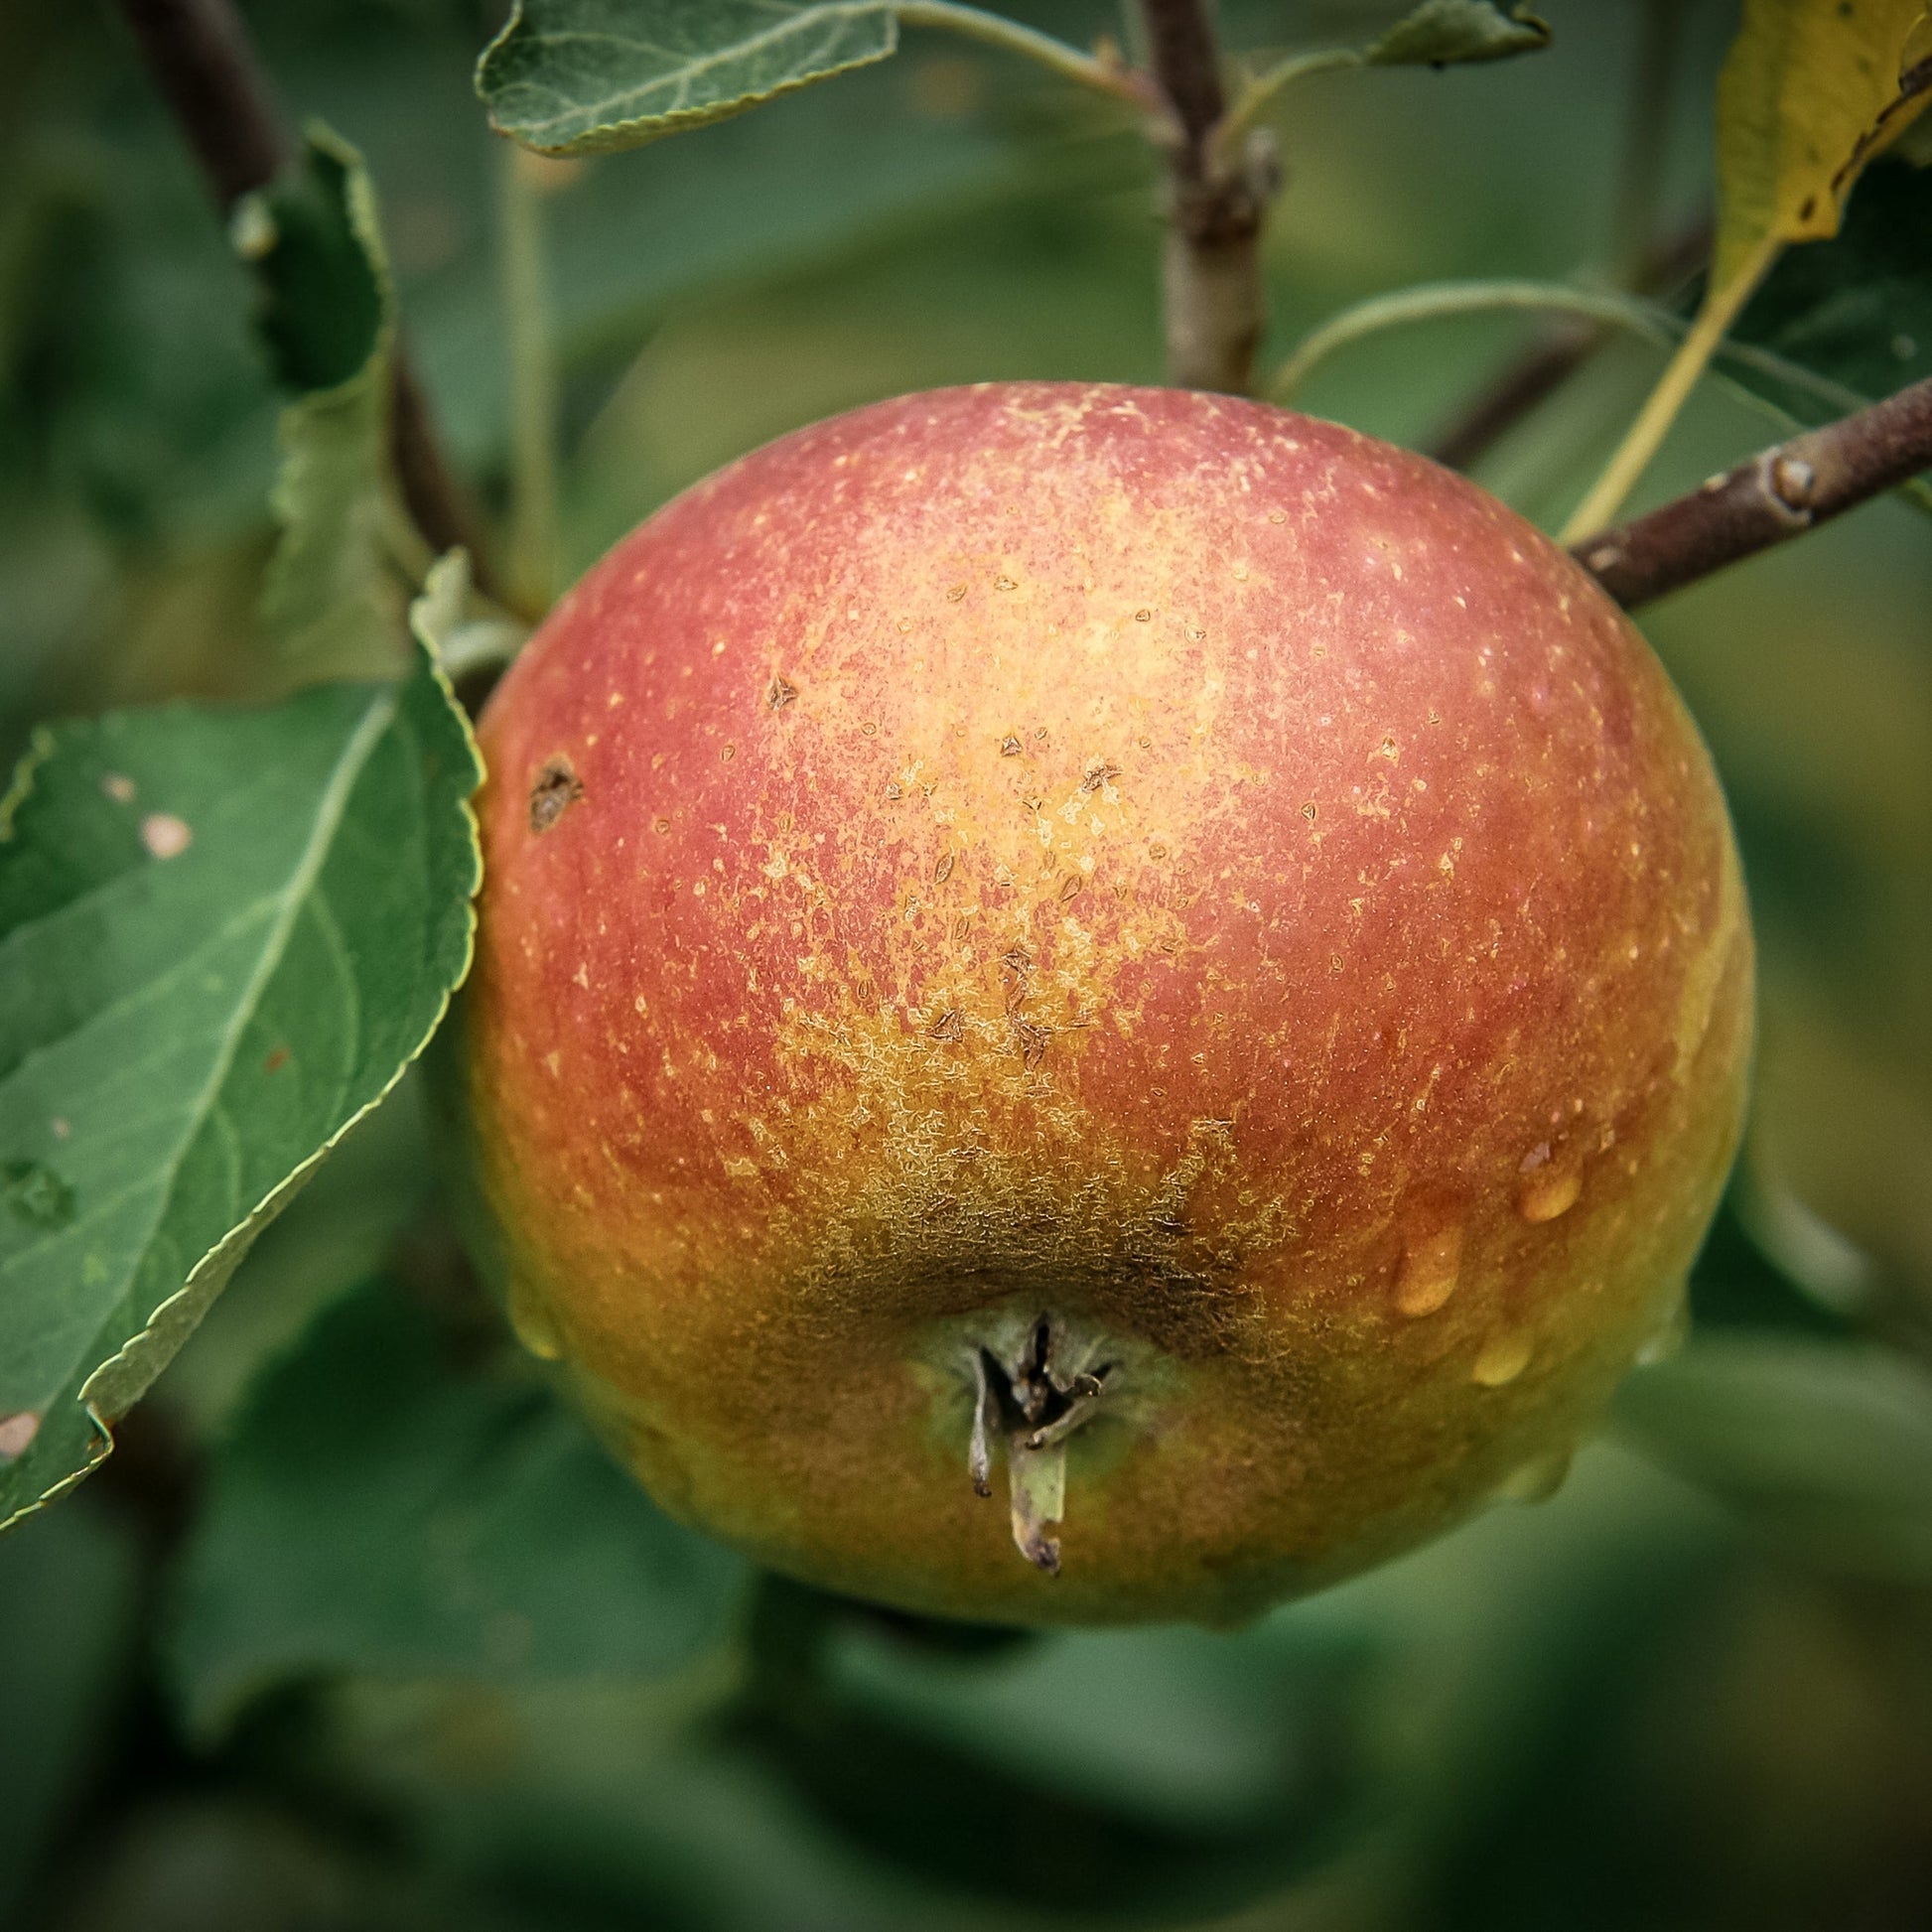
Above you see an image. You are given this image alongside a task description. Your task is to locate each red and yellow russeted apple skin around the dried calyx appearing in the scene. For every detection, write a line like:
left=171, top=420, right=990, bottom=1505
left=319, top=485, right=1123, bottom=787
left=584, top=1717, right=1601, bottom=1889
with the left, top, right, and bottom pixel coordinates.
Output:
left=458, top=384, right=1752, bottom=1623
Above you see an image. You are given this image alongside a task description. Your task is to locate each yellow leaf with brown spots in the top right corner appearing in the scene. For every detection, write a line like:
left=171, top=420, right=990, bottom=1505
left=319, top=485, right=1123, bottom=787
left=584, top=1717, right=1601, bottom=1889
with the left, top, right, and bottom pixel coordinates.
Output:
left=1712, top=0, right=1932, bottom=290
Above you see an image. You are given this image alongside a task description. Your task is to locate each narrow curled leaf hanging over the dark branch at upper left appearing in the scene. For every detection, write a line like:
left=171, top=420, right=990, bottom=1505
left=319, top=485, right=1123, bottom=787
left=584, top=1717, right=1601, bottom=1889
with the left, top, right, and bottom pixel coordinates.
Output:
left=249, top=122, right=400, bottom=668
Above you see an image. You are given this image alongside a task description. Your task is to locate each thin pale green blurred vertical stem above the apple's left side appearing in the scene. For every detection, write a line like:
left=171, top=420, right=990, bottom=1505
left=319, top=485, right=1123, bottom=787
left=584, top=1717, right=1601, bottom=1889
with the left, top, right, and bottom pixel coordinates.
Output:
left=496, top=141, right=556, bottom=617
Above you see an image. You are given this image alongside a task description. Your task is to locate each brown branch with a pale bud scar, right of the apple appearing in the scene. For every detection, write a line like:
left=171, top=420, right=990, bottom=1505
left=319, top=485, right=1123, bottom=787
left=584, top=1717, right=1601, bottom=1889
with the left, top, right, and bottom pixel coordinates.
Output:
left=1571, top=376, right=1932, bottom=611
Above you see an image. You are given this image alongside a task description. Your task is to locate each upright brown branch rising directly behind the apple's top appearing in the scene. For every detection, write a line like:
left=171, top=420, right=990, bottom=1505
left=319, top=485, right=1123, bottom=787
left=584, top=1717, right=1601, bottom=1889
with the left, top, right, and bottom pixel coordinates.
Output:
left=1140, top=0, right=1275, bottom=394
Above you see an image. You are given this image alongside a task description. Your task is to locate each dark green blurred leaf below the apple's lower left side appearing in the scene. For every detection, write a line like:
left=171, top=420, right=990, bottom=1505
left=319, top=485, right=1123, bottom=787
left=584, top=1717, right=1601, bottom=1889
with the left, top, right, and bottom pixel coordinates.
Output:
left=172, top=1281, right=748, bottom=1727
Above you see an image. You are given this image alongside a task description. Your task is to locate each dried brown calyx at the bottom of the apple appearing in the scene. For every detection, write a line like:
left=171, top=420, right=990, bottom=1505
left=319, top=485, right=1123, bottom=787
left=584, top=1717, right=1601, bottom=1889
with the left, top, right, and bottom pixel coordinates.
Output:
left=966, top=1315, right=1119, bottom=1577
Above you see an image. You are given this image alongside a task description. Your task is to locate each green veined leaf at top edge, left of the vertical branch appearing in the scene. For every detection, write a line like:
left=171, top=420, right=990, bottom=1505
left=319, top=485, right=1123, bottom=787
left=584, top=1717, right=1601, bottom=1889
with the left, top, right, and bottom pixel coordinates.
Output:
left=478, top=0, right=898, bottom=155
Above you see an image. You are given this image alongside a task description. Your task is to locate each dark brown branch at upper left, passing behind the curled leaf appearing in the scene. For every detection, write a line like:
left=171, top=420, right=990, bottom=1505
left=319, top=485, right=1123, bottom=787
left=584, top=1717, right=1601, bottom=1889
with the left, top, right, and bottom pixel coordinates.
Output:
left=120, top=0, right=488, bottom=588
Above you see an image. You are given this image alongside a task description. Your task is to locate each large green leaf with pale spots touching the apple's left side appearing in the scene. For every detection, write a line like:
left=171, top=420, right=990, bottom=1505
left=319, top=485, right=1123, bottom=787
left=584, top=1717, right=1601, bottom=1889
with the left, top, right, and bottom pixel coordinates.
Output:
left=0, top=653, right=482, bottom=1526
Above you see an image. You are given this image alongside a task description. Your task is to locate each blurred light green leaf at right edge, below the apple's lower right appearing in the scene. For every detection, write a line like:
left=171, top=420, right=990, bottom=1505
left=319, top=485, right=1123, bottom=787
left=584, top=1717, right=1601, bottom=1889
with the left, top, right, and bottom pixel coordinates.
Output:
left=1617, top=1335, right=1932, bottom=1585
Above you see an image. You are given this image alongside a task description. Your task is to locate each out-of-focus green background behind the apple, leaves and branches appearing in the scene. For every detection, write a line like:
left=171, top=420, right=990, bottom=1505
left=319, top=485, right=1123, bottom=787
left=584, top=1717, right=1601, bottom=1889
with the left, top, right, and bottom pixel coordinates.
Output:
left=0, top=0, right=1932, bottom=1932
